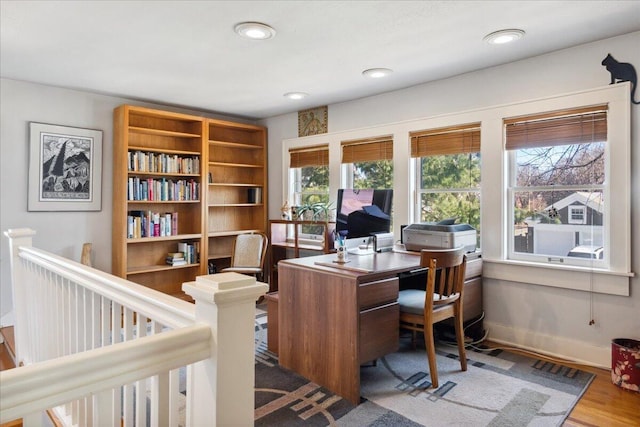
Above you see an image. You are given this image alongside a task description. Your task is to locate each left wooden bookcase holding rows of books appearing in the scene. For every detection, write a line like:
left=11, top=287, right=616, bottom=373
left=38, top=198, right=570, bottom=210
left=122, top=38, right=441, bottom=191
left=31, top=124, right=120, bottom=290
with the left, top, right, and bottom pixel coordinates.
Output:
left=112, top=105, right=208, bottom=298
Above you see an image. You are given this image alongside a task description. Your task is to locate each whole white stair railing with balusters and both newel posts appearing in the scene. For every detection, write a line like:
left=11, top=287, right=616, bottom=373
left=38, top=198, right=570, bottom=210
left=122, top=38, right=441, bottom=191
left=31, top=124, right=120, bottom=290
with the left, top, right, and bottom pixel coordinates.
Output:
left=0, top=229, right=267, bottom=426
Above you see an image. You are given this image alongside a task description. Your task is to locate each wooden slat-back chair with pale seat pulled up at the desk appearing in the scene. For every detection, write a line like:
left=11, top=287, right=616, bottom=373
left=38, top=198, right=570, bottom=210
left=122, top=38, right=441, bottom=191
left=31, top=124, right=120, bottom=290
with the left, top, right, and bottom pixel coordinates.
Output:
left=398, top=248, right=467, bottom=388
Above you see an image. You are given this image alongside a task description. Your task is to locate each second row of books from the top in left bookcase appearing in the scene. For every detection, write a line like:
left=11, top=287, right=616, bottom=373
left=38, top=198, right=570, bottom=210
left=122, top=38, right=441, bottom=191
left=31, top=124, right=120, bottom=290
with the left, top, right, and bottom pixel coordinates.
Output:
left=127, top=176, right=200, bottom=201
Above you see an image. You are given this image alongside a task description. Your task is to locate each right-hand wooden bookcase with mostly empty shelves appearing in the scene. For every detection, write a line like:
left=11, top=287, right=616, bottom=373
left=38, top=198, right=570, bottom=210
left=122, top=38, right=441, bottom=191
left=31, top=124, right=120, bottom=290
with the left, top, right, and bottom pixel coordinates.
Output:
left=206, top=119, right=267, bottom=271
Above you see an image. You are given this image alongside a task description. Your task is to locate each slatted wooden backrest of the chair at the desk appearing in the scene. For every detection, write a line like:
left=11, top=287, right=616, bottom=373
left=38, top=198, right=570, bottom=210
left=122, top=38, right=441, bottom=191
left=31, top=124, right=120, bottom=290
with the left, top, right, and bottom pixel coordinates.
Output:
left=420, top=248, right=467, bottom=305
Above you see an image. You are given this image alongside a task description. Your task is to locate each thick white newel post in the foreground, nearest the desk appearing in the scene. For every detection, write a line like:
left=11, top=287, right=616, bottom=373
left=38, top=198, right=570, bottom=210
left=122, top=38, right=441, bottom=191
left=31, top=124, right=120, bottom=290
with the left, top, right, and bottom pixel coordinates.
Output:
left=182, top=273, right=268, bottom=426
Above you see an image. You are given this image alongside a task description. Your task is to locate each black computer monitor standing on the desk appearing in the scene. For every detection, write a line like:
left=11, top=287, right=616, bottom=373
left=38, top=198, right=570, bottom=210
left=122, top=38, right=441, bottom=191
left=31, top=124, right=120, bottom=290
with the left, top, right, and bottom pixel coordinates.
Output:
left=336, top=189, right=393, bottom=239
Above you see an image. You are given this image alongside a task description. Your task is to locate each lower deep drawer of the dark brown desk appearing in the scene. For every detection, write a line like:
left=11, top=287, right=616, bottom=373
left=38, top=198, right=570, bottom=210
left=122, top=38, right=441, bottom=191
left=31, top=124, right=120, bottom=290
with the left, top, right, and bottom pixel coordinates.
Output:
left=358, top=302, right=400, bottom=363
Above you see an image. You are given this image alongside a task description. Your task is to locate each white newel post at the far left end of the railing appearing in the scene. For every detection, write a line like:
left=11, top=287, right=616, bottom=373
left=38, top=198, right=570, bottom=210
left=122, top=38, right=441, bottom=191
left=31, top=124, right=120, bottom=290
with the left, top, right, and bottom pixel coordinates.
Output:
left=4, top=228, right=36, bottom=364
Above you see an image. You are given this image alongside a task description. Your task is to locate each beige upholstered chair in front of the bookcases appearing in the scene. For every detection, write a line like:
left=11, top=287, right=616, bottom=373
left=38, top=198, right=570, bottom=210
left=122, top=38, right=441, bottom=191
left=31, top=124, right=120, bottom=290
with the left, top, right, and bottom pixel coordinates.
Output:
left=221, top=233, right=269, bottom=280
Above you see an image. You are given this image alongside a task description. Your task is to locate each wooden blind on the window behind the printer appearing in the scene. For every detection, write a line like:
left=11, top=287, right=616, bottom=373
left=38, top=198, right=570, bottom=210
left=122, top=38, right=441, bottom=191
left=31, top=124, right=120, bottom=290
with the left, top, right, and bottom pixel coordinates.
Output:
left=409, top=123, right=480, bottom=157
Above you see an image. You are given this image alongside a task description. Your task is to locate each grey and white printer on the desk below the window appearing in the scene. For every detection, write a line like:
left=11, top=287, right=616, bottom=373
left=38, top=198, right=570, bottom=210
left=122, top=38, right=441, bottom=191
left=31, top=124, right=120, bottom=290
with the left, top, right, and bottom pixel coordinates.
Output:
left=402, top=222, right=476, bottom=252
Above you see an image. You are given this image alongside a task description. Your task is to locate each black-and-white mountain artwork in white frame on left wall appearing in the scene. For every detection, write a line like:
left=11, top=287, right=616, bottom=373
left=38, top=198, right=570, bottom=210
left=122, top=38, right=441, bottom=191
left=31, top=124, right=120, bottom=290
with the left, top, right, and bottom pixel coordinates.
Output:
left=27, top=122, right=102, bottom=211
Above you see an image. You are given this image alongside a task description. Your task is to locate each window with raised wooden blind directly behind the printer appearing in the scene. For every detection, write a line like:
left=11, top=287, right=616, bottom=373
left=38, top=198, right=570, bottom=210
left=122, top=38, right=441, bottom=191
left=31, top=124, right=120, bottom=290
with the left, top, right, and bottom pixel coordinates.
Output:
left=410, top=124, right=480, bottom=247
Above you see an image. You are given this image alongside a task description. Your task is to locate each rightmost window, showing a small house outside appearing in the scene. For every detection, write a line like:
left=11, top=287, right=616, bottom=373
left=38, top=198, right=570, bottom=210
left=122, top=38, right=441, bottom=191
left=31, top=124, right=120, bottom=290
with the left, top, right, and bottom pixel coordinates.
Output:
left=504, top=105, right=607, bottom=265
